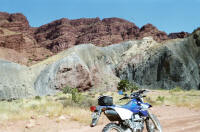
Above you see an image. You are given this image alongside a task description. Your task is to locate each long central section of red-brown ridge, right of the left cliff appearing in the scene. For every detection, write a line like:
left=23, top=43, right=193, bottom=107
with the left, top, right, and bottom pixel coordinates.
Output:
left=35, top=18, right=139, bottom=53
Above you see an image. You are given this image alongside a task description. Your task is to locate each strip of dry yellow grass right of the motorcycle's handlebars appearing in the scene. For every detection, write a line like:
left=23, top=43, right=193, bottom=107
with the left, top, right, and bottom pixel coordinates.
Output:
left=146, top=88, right=200, bottom=109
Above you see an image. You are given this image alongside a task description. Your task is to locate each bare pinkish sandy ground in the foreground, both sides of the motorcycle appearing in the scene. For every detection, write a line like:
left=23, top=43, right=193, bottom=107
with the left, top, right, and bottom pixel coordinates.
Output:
left=0, top=106, right=200, bottom=132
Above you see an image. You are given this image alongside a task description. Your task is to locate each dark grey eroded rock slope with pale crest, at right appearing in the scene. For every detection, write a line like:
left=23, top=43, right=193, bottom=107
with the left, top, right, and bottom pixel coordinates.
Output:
left=116, top=33, right=200, bottom=90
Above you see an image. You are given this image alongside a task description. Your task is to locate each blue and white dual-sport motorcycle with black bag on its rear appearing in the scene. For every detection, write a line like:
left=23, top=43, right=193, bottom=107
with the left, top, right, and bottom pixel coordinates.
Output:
left=90, top=90, right=162, bottom=132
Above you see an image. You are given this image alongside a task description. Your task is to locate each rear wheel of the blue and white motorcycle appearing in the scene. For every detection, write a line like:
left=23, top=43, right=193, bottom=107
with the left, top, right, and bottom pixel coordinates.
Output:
left=102, top=123, right=123, bottom=132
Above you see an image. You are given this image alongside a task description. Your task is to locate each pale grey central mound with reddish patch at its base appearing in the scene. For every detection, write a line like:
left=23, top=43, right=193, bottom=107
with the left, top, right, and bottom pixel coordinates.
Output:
left=35, top=42, right=132, bottom=95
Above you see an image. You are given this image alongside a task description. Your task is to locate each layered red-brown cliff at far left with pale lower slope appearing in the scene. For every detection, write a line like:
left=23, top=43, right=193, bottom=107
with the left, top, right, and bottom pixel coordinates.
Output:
left=0, top=12, right=52, bottom=65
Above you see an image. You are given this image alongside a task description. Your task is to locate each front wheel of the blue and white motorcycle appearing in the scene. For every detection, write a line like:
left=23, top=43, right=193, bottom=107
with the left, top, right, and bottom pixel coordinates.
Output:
left=146, top=114, right=162, bottom=132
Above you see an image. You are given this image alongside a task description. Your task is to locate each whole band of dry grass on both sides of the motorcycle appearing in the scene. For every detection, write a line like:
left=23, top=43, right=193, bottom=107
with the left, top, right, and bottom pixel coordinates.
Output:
left=0, top=90, right=200, bottom=124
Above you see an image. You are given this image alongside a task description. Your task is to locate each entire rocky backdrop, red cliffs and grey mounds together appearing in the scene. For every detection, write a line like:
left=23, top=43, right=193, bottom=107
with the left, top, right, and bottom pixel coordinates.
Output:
left=0, top=12, right=200, bottom=99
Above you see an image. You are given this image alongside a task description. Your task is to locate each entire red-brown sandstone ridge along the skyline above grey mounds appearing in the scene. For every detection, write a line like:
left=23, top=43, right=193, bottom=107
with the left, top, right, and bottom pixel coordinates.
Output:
left=0, top=12, right=187, bottom=66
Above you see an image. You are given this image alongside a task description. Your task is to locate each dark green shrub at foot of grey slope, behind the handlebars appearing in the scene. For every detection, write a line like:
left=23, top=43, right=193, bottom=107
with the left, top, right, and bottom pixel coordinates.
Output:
left=117, top=80, right=139, bottom=92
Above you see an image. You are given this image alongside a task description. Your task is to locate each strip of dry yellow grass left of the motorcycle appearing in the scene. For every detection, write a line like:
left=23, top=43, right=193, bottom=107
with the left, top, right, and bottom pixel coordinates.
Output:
left=0, top=93, right=96, bottom=124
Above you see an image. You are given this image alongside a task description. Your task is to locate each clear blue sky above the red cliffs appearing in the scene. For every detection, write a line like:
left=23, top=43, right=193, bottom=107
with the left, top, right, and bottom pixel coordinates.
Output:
left=0, top=0, right=200, bottom=33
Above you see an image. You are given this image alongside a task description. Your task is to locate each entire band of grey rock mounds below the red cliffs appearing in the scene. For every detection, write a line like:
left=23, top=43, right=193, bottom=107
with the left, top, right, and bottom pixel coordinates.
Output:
left=0, top=30, right=200, bottom=99
